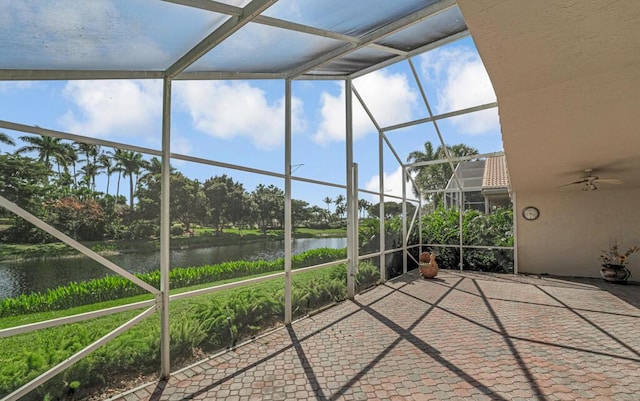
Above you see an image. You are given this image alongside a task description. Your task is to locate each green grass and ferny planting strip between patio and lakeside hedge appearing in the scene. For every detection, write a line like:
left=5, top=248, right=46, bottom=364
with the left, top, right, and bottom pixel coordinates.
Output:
left=0, top=265, right=356, bottom=400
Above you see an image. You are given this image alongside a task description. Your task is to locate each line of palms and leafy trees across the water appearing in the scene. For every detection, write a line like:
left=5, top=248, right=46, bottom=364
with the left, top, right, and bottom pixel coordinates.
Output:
left=0, top=133, right=368, bottom=242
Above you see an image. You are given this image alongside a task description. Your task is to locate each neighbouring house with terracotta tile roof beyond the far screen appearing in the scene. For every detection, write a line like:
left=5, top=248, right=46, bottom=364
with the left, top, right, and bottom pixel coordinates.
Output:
left=444, top=155, right=511, bottom=214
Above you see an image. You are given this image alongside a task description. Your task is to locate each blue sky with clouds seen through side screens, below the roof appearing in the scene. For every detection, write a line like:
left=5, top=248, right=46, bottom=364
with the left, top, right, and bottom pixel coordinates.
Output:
left=0, top=38, right=502, bottom=206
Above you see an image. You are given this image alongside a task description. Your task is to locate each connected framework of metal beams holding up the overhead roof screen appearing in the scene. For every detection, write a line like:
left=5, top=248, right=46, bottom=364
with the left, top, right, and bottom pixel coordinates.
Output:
left=0, top=0, right=469, bottom=81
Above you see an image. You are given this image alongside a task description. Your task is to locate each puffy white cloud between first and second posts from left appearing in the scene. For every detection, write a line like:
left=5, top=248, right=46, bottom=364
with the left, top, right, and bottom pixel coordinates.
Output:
left=174, top=81, right=304, bottom=150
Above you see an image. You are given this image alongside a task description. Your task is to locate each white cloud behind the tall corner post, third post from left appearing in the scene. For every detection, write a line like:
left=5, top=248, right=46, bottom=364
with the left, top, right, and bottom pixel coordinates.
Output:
left=313, top=71, right=417, bottom=144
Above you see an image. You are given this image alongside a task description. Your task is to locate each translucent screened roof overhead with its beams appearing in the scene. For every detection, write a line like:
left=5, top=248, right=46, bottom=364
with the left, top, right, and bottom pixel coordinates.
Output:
left=0, top=0, right=467, bottom=80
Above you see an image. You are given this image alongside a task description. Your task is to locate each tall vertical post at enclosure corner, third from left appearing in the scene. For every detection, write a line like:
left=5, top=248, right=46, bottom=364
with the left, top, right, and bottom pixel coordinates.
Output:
left=344, top=78, right=358, bottom=299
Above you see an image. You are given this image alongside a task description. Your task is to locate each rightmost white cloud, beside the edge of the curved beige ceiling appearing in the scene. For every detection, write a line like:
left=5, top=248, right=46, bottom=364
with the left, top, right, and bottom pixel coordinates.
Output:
left=420, top=46, right=500, bottom=135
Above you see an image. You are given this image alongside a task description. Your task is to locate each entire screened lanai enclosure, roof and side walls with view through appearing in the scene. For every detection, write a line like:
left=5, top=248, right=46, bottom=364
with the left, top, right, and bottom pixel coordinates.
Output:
left=0, top=0, right=517, bottom=400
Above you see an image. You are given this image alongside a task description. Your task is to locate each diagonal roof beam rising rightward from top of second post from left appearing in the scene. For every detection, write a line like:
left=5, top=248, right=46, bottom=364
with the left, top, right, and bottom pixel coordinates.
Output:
left=288, top=0, right=457, bottom=78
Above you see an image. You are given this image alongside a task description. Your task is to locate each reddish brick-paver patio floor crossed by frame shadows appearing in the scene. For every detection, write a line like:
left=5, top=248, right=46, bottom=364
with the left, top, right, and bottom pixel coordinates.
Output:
left=112, top=271, right=640, bottom=401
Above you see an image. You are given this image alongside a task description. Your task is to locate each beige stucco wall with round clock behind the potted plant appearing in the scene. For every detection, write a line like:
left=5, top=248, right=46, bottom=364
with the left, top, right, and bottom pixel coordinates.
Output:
left=516, top=188, right=640, bottom=281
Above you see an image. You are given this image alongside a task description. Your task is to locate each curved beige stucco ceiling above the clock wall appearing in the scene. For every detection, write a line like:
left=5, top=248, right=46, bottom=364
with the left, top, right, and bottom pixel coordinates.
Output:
left=458, top=0, right=640, bottom=192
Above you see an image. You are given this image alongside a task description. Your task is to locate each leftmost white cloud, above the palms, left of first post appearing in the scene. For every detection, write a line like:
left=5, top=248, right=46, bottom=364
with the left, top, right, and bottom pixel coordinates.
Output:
left=60, top=80, right=162, bottom=138
